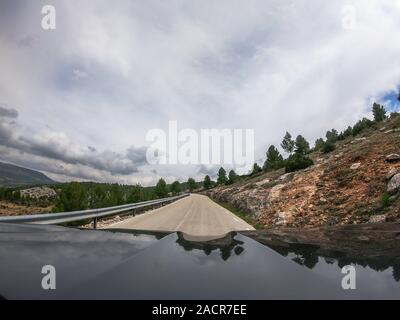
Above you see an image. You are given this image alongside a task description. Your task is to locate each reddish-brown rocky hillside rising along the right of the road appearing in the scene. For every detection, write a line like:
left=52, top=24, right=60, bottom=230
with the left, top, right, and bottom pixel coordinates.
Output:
left=208, top=112, right=400, bottom=227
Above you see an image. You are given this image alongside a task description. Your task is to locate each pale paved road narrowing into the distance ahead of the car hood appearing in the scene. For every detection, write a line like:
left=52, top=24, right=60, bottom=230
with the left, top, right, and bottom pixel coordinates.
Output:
left=107, top=194, right=254, bottom=237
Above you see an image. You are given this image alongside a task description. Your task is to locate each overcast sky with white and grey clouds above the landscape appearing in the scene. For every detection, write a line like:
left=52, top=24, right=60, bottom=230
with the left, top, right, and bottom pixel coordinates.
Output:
left=0, top=0, right=400, bottom=185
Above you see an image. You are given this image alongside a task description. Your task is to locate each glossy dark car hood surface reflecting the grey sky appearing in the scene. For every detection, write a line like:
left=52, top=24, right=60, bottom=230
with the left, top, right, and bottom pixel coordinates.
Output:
left=0, top=224, right=400, bottom=299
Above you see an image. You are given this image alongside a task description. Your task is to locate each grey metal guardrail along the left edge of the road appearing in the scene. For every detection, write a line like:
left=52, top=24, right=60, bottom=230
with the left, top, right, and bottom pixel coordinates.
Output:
left=0, top=193, right=189, bottom=229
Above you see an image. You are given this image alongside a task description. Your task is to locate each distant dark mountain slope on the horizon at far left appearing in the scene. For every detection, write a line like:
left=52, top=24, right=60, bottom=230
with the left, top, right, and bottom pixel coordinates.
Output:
left=0, top=162, right=56, bottom=187
